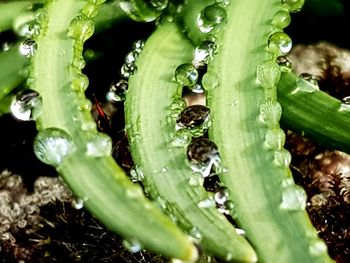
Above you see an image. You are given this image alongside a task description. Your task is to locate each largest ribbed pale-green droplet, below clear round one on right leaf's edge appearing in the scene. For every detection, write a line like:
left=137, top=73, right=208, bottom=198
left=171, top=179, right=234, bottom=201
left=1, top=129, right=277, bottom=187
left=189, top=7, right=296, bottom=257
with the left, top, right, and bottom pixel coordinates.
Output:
left=256, top=61, right=281, bottom=89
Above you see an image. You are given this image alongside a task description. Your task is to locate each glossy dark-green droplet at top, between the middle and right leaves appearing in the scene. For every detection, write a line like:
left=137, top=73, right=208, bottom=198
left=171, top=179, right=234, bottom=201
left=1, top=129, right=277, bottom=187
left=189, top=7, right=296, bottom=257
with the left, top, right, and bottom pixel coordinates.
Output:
left=197, top=4, right=227, bottom=33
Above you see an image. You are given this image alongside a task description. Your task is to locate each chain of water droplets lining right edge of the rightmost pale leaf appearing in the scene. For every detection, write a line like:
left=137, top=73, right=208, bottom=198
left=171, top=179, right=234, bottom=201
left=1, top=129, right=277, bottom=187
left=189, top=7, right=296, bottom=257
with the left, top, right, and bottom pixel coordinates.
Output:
left=256, top=0, right=310, bottom=214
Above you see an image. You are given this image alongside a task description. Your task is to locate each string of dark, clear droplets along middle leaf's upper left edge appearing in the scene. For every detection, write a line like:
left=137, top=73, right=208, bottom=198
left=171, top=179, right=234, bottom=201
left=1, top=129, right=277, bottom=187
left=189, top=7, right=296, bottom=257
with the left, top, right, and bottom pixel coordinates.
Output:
left=106, top=40, right=145, bottom=103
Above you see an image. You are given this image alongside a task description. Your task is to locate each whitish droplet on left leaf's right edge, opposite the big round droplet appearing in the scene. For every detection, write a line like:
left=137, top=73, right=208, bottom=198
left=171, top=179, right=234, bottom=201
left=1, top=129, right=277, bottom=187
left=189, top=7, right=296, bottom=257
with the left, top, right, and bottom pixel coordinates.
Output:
left=86, top=133, right=112, bottom=157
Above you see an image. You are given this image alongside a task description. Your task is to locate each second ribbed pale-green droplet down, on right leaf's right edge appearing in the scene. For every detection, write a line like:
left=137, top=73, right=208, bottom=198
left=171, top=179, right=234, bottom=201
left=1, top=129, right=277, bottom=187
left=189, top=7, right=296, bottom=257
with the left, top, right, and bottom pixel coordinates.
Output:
left=259, top=101, right=282, bottom=128
